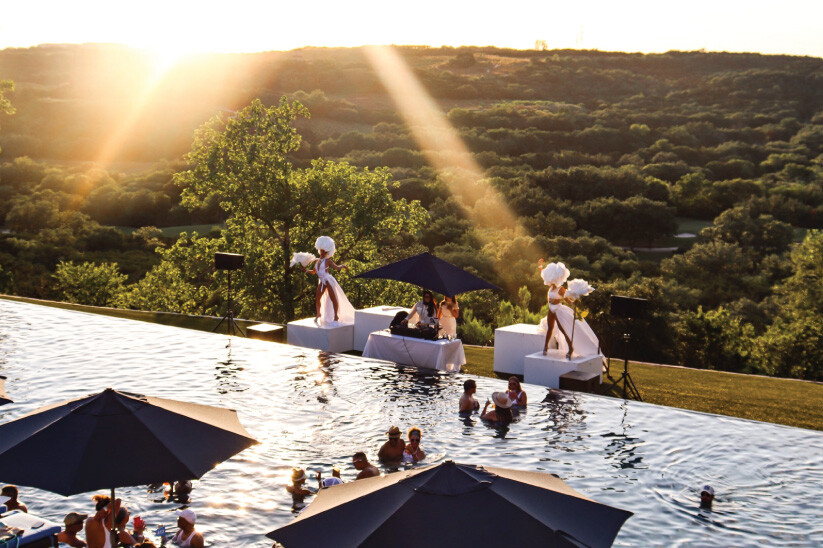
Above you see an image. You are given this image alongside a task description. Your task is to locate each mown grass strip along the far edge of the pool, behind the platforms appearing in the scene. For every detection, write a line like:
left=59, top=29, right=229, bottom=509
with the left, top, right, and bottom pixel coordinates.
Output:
left=6, top=295, right=823, bottom=430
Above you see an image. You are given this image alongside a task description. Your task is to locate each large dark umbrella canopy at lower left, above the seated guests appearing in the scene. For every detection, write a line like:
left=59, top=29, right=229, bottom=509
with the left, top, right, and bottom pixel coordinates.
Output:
left=0, top=388, right=257, bottom=496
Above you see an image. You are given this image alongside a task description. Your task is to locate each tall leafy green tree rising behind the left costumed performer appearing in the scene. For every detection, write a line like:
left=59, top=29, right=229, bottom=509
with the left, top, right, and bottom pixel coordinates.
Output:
left=174, top=98, right=425, bottom=321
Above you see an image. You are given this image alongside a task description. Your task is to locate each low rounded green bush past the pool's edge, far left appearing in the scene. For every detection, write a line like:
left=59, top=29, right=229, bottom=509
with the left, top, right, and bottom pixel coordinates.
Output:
left=54, top=261, right=126, bottom=306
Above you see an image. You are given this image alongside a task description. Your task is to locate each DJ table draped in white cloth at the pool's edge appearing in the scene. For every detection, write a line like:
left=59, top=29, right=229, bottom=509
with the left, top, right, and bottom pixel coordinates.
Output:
left=363, top=331, right=466, bottom=371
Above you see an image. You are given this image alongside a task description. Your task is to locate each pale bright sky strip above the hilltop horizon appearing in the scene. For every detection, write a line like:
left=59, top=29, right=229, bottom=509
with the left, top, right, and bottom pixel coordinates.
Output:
left=0, top=0, right=823, bottom=57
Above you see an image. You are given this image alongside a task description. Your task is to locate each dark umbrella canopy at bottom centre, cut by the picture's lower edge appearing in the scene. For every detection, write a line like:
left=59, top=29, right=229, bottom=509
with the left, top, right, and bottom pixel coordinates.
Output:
left=266, top=461, right=632, bottom=548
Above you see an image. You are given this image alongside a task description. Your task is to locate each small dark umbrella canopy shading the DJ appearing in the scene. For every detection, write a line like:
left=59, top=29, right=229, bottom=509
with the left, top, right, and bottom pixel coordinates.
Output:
left=355, top=253, right=500, bottom=297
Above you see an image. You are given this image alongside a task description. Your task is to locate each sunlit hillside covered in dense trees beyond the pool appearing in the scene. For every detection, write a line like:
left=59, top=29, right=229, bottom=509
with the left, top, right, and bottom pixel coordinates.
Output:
left=0, top=46, right=823, bottom=379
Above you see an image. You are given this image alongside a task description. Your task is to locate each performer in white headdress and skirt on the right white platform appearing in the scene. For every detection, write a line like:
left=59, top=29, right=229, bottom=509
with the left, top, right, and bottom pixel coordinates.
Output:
left=538, top=259, right=600, bottom=359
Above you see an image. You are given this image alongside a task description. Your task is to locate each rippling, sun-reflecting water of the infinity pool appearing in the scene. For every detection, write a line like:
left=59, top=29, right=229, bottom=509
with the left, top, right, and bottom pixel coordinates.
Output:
left=0, top=300, right=823, bottom=547
